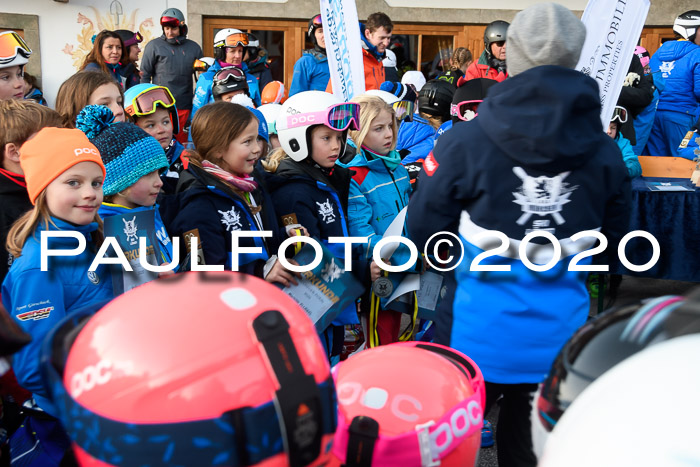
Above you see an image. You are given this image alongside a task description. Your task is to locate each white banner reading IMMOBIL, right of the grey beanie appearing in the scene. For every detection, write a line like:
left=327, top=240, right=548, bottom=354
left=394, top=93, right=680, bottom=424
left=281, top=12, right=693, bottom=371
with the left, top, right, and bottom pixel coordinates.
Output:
left=576, top=0, right=650, bottom=129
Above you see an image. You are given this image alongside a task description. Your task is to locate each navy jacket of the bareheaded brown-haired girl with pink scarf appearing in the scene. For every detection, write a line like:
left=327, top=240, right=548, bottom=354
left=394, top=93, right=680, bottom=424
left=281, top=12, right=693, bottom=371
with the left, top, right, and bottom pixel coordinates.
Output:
left=161, top=164, right=280, bottom=277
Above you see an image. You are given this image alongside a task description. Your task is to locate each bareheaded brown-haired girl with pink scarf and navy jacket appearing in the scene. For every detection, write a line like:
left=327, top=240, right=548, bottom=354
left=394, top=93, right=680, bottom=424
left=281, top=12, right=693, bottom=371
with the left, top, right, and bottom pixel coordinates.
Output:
left=164, top=101, right=296, bottom=286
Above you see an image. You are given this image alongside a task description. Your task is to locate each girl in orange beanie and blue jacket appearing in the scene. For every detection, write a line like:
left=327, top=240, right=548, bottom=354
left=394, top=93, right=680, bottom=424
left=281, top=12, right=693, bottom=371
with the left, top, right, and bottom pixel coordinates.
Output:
left=2, top=128, right=113, bottom=415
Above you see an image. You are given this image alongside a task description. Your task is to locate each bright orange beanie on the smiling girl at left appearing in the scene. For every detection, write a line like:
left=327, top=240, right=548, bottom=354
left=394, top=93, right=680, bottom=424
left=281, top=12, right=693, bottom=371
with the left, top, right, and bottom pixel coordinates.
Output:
left=19, top=128, right=105, bottom=204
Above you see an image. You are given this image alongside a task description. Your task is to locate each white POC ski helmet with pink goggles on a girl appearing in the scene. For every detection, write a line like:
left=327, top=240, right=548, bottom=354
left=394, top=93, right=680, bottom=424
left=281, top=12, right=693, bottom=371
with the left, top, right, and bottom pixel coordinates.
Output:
left=275, top=91, right=359, bottom=162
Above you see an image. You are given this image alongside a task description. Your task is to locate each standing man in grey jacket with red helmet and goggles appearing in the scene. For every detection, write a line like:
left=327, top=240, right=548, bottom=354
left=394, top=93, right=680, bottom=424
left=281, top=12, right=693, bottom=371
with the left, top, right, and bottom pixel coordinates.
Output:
left=141, top=8, right=203, bottom=144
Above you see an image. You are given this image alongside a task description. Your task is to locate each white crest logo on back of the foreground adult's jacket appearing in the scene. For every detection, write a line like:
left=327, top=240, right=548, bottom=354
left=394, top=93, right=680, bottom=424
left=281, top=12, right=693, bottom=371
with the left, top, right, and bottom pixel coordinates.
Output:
left=513, top=167, right=578, bottom=225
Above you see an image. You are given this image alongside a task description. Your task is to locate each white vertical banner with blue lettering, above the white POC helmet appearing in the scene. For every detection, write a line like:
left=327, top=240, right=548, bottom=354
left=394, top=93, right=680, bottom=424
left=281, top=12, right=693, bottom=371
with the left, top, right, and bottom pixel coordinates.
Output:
left=321, top=0, right=365, bottom=101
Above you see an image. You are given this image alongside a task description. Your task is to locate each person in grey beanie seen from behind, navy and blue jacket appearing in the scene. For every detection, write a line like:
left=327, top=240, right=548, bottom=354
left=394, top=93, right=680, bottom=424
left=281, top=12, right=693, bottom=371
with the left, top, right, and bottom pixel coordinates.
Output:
left=407, top=3, right=630, bottom=466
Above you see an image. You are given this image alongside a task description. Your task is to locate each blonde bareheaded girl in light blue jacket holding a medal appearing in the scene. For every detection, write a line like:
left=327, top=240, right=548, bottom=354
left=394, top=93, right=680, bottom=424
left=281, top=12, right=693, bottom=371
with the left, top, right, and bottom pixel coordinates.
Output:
left=347, top=95, right=411, bottom=344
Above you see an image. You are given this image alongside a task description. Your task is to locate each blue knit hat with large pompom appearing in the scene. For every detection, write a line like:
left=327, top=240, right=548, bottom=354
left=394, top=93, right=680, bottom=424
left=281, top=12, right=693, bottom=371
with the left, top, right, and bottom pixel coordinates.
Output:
left=76, top=105, right=168, bottom=196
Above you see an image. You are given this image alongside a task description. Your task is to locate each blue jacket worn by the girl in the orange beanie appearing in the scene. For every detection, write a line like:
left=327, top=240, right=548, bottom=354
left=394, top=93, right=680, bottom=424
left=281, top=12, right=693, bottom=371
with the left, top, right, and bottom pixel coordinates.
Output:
left=2, top=217, right=114, bottom=415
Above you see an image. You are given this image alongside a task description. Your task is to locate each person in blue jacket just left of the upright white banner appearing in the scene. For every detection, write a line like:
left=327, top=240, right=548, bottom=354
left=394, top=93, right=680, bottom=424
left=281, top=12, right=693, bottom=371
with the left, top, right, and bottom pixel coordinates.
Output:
left=289, top=15, right=331, bottom=97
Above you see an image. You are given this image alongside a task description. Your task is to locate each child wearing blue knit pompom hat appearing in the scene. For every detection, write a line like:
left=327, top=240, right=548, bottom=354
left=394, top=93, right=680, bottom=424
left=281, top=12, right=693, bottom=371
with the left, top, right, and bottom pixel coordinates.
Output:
left=77, top=105, right=173, bottom=293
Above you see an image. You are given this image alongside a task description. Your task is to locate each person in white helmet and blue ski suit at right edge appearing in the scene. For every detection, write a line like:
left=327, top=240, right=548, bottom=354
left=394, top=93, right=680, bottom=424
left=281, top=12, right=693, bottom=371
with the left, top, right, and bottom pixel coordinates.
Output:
left=647, top=10, right=700, bottom=156
